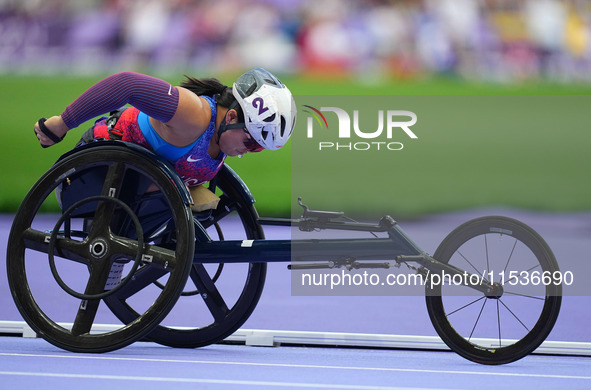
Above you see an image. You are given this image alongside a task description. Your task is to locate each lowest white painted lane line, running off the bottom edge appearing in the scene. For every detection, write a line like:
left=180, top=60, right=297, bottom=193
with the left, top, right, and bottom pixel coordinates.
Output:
left=0, top=371, right=454, bottom=390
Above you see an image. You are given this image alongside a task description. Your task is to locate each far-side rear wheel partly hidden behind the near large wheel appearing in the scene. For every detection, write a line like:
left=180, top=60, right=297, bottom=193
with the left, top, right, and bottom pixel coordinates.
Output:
left=106, top=165, right=267, bottom=348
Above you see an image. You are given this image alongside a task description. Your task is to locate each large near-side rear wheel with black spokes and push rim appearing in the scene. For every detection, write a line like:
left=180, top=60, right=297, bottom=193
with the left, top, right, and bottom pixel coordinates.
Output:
left=7, top=143, right=195, bottom=352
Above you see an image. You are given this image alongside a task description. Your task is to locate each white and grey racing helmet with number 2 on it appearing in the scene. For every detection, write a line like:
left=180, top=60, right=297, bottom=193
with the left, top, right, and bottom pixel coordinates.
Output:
left=232, top=68, right=297, bottom=150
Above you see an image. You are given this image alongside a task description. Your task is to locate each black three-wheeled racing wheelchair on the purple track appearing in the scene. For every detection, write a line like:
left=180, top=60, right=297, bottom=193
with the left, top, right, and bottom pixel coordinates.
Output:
left=7, top=141, right=562, bottom=364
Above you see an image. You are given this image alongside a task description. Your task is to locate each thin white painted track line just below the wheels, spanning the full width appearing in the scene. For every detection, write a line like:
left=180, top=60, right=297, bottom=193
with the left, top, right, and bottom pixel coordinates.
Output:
left=0, top=352, right=591, bottom=380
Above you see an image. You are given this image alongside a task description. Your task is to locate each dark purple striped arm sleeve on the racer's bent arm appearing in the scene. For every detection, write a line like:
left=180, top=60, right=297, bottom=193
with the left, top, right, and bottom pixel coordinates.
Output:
left=62, top=72, right=179, bottom=129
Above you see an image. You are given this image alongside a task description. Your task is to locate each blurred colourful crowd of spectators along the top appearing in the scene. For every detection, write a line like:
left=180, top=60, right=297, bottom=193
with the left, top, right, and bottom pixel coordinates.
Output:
left=0, top=0, right=591, bottom=82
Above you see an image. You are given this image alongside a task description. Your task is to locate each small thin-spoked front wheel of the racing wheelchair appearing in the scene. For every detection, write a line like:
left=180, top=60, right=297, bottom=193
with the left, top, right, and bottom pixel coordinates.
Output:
left=426, top=217, right=562, bottom=364
